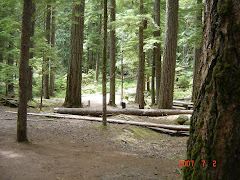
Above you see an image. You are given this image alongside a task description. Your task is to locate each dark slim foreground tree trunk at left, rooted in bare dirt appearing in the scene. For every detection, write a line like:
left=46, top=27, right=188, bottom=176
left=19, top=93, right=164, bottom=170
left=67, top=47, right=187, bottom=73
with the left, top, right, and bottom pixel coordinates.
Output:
left=17, top=0, right=33, bottom=142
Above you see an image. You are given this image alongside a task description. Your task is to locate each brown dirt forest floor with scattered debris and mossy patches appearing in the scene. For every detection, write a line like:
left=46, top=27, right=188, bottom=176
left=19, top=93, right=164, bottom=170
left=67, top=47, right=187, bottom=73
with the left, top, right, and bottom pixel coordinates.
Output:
left=0, top=92, right=188, bottom=180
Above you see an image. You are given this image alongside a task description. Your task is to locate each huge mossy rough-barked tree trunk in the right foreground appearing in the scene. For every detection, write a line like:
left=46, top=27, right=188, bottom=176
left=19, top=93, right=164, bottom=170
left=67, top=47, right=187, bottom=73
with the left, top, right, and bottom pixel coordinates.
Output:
left=183, top=0, right=240, bottom=180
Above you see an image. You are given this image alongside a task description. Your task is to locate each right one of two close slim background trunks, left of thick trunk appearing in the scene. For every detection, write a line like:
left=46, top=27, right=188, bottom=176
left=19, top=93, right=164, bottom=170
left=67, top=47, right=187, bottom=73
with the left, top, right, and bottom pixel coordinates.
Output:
left=50, top=7, right=55, bottom=96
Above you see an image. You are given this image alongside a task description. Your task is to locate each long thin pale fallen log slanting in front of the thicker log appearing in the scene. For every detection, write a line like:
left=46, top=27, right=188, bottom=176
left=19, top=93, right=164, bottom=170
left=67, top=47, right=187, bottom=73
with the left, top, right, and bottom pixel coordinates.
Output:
left=6, top=111, right=190, bottom=131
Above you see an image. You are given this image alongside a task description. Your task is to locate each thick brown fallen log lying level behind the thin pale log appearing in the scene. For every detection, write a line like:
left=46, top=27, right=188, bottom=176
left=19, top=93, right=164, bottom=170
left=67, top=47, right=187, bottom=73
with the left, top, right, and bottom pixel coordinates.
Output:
left=54, top=108, right=193, bottom=116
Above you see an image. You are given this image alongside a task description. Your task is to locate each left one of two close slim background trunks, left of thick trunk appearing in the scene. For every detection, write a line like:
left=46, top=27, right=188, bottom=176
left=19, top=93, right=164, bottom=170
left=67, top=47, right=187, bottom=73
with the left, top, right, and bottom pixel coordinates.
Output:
left=44, top=5, right=51, bottom=99
